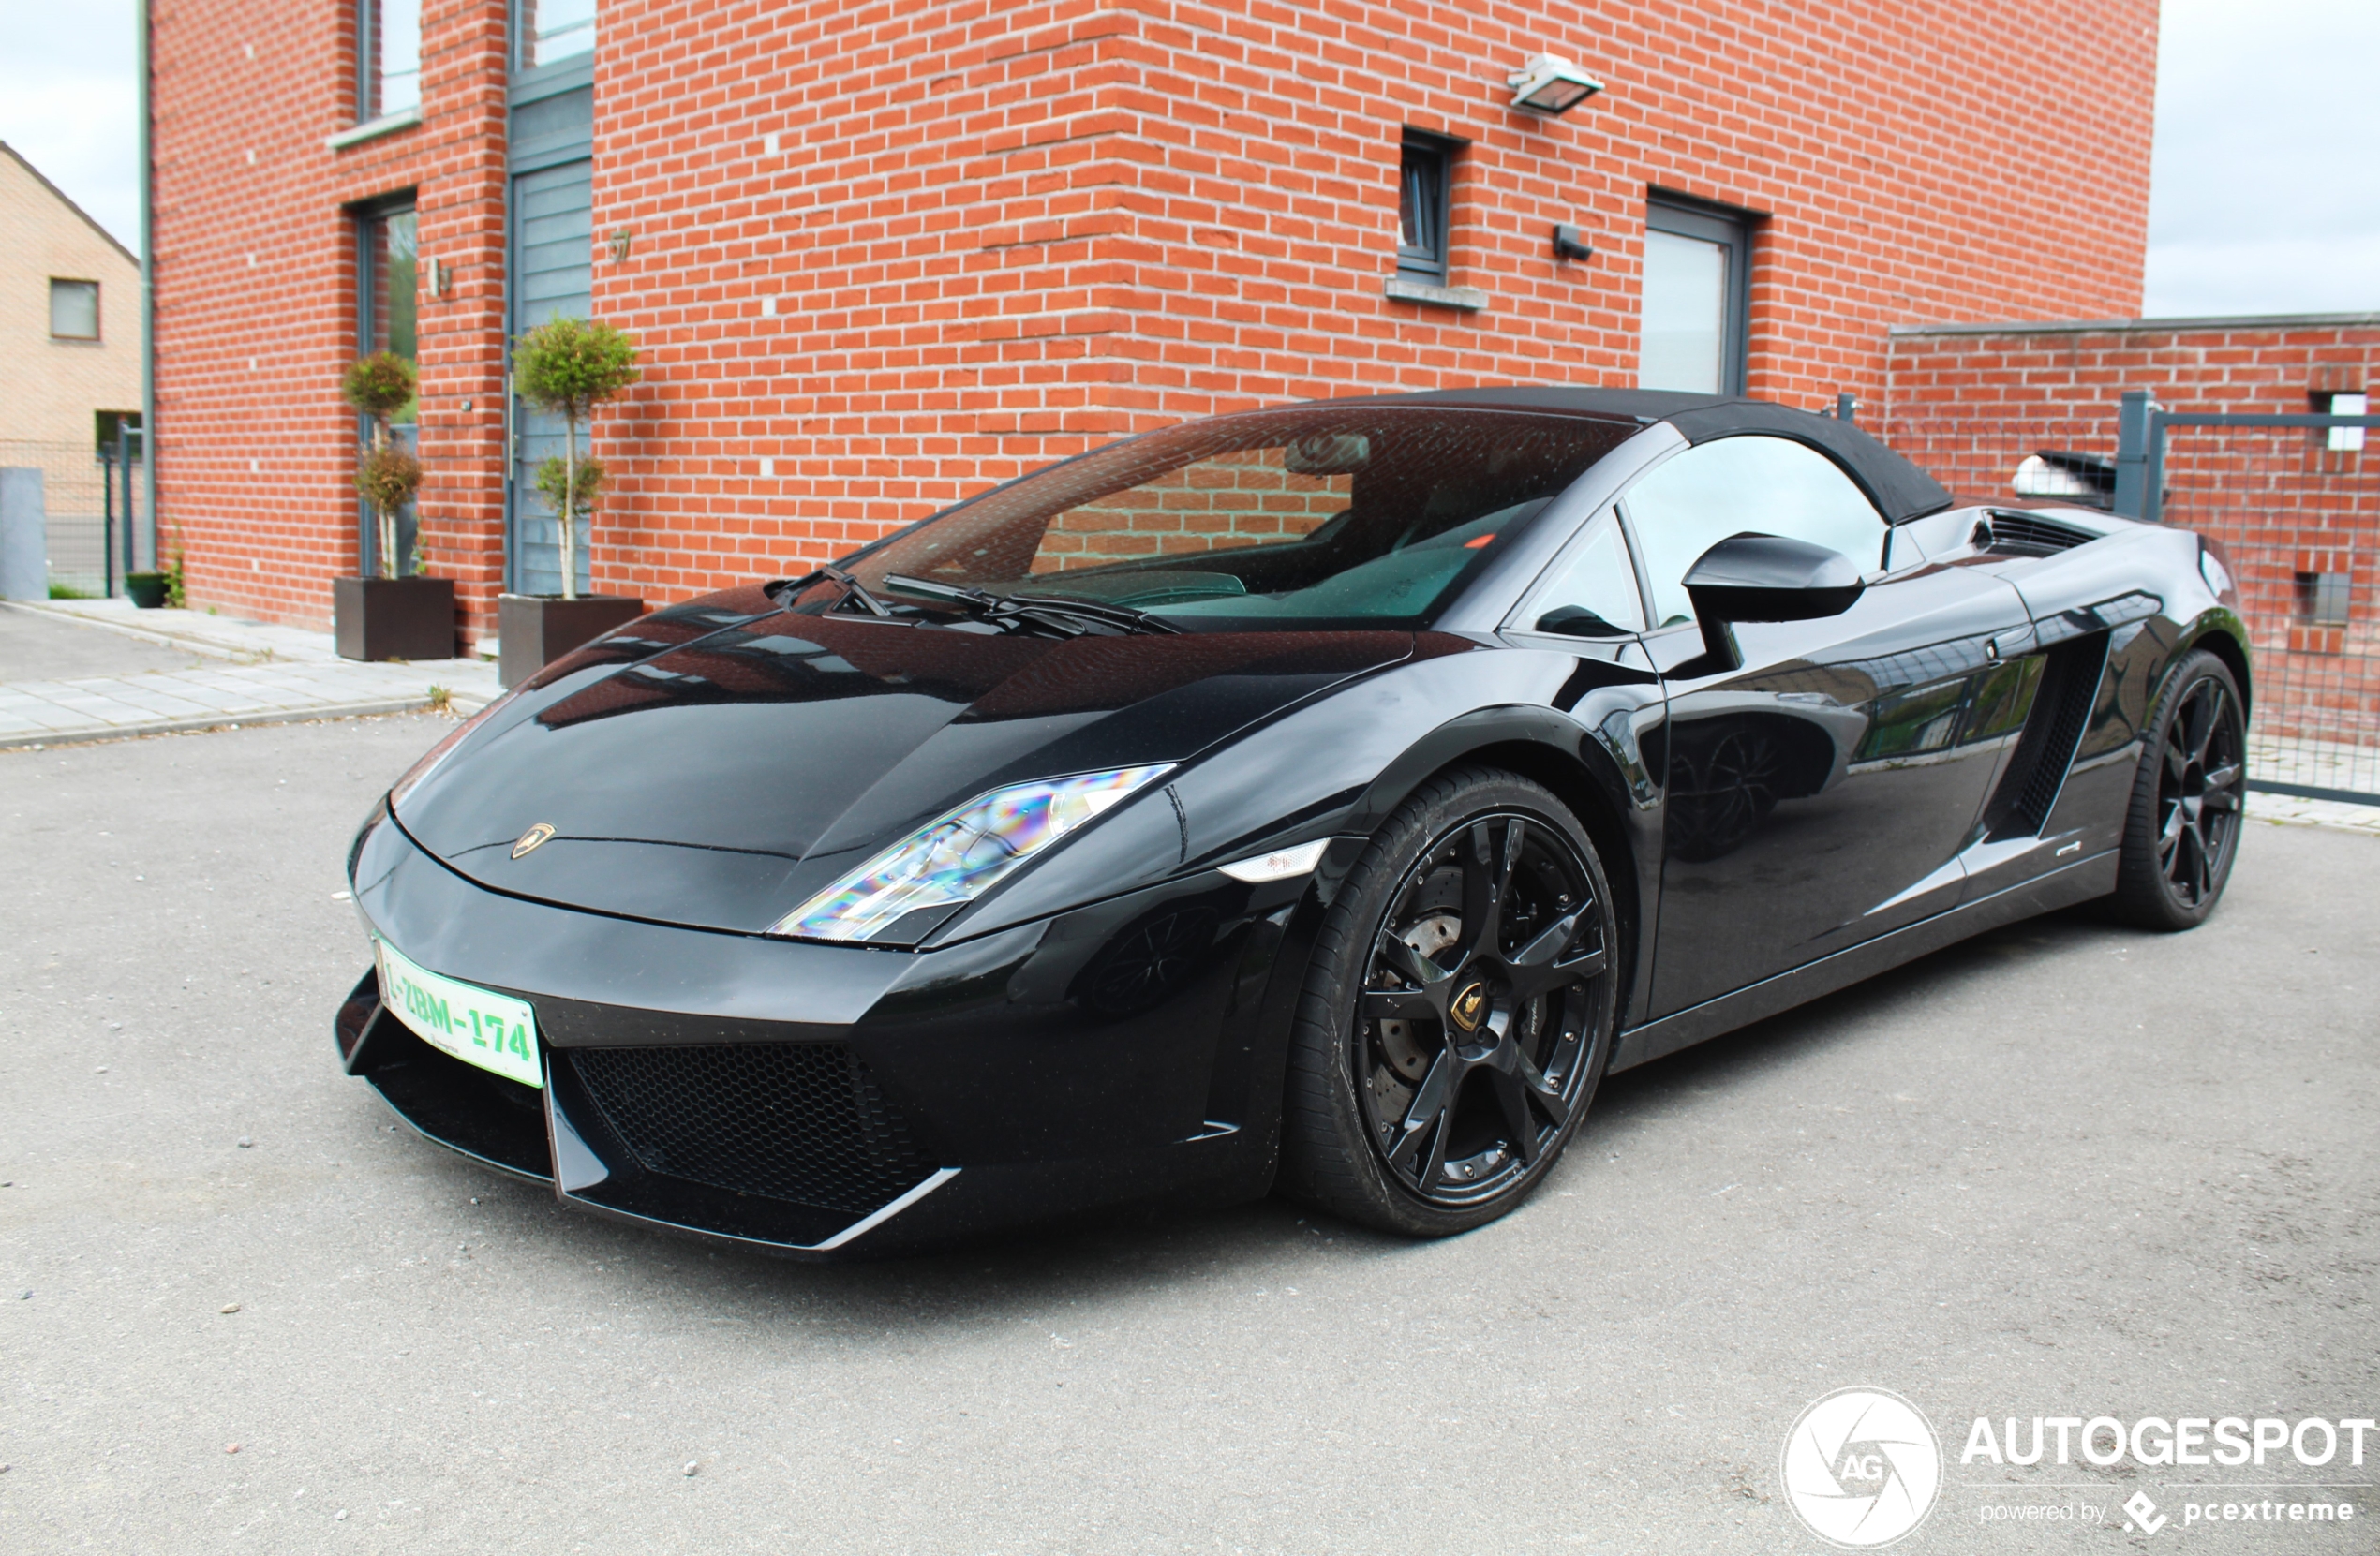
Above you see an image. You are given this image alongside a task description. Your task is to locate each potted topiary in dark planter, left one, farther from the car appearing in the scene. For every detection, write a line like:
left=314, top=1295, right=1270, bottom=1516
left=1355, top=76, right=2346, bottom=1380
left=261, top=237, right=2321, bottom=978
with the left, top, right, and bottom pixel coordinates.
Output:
left=331, top=352, right=454, bottom=659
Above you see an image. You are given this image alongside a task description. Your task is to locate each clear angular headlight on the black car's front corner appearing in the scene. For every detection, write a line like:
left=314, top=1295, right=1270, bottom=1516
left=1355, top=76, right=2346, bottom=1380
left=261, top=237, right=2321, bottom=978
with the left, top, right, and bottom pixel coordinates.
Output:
left=768, top=763, right=1173, bottom=944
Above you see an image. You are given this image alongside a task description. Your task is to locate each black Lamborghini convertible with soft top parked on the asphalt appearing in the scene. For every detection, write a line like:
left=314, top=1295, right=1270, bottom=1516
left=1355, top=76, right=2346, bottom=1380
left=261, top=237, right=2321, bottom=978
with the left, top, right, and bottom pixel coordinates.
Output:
left=335, top=391, right=2249, bottom=1253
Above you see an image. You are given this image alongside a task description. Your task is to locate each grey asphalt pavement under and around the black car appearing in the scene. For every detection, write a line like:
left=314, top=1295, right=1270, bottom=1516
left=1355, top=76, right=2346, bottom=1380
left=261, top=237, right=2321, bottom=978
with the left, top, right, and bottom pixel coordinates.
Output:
left=0, top=716, right=2380, bottom=1553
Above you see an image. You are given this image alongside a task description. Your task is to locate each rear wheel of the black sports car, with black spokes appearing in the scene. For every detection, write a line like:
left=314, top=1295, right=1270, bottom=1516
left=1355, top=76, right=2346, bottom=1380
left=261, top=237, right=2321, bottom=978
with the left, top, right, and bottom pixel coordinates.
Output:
left=2111, top=649, right=2247, bottom=930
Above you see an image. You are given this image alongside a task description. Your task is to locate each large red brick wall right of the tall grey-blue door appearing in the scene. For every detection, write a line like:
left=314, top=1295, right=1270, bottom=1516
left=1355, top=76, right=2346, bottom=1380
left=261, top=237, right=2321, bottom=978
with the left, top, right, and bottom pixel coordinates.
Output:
left=595, top=0, right=2154, bottom=597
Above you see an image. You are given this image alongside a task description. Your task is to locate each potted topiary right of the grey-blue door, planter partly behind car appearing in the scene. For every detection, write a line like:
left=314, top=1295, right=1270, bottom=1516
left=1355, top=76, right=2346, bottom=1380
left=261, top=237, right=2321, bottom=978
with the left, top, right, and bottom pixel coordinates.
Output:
left=495, top=319, right=645, bottom=685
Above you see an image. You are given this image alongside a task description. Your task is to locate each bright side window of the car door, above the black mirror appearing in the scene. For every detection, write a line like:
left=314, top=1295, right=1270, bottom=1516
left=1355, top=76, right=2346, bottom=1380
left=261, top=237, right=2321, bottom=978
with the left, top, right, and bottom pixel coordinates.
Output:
left=1621, top=436, right=1890, bottom=626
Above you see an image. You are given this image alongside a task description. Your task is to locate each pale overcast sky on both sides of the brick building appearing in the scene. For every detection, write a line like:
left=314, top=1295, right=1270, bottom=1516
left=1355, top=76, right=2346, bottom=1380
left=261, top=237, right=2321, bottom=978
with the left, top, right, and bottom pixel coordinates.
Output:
left=0, top=0, right=2380, bottom=317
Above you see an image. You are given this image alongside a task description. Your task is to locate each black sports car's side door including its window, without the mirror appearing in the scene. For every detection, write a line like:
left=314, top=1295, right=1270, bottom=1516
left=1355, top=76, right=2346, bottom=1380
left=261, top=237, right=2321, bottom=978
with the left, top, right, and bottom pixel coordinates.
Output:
left=1621, top=436, right=2028, bottom=1015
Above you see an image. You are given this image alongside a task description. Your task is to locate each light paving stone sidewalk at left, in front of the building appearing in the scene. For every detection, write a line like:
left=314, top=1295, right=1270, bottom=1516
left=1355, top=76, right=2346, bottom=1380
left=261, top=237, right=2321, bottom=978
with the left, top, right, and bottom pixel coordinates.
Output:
left=0, top=600, right=499, bottom=749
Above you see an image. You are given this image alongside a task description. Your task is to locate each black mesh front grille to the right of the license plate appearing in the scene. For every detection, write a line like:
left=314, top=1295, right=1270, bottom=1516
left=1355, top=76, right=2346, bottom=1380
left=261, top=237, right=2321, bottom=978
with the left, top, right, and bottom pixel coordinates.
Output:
left=569, top=1042, right=933, bottom=1216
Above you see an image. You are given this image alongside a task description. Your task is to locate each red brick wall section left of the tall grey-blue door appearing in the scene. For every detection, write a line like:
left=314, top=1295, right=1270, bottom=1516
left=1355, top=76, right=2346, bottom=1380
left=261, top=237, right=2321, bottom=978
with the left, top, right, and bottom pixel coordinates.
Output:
left=153, top=0, right=507, bottom=626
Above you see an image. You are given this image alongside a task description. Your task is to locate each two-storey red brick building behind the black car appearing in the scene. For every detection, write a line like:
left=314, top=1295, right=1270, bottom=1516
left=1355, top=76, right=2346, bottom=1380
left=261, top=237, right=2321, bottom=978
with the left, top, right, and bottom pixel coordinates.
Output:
left=150, top=0, right=2156, bottom=638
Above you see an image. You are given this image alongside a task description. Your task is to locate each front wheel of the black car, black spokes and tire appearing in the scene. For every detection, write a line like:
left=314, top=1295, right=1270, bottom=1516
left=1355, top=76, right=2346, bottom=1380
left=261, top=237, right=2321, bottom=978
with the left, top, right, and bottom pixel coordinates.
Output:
left=1278, top=768, right=1621, bottom=1237
